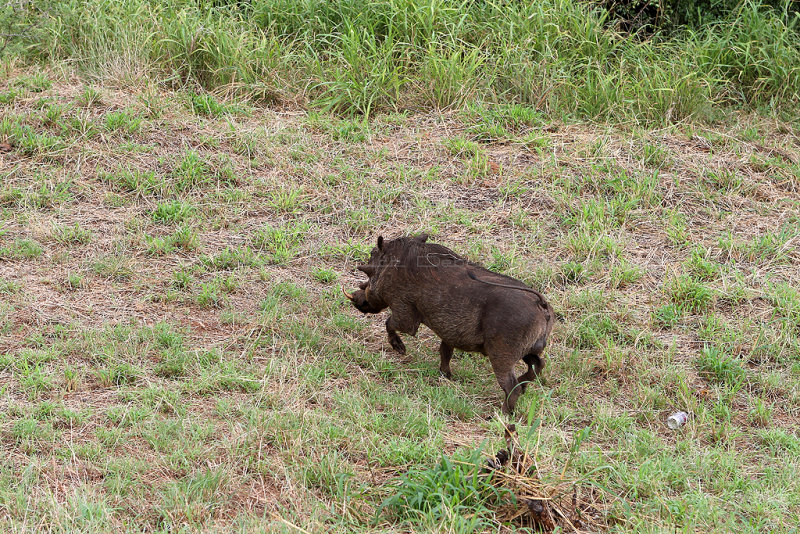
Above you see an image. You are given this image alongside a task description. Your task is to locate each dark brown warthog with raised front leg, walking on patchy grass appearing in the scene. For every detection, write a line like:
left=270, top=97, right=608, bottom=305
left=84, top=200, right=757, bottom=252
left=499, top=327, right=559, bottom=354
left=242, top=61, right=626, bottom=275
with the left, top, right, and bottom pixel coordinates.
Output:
left=342, top=235, right=555, bottom=414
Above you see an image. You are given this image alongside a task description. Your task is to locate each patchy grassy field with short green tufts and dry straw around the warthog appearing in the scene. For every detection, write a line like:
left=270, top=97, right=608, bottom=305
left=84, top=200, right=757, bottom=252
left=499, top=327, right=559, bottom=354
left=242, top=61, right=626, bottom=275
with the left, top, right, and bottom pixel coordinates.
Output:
left=0, top=0, right=800, bottom=532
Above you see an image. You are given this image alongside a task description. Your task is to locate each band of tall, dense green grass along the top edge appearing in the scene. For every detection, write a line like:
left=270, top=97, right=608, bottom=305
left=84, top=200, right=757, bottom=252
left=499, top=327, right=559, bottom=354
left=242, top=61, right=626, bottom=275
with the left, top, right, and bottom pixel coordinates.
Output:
left=6, top=0, right=800, bottom=125
